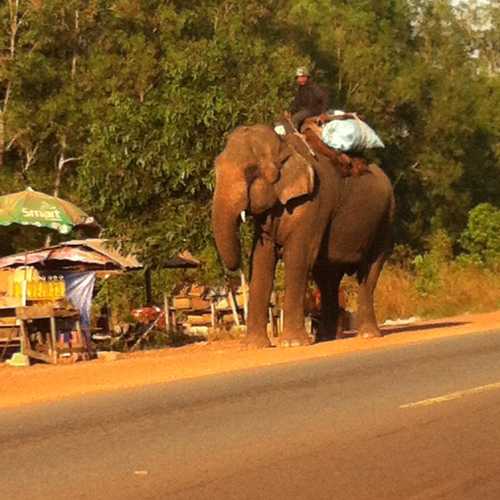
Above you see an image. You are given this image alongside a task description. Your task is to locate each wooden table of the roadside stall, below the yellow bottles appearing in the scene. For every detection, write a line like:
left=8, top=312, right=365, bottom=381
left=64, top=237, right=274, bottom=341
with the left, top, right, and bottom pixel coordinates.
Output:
left=16, top=305, right=88, bottom=364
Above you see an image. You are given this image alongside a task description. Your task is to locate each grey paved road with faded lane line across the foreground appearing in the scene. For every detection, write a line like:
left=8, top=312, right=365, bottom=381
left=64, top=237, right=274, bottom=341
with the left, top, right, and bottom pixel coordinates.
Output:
left=0, top=331, right=500, bottom=500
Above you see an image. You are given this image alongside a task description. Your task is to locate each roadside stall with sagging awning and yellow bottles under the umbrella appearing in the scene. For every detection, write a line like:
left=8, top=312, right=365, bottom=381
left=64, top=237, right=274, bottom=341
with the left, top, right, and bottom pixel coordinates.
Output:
left=0, top=239, right=142, bottom=363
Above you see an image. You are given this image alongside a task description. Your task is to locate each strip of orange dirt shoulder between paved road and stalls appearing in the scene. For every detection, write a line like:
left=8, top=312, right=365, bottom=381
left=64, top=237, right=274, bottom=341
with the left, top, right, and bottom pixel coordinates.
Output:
left=0, top=310, right=500, bottom=409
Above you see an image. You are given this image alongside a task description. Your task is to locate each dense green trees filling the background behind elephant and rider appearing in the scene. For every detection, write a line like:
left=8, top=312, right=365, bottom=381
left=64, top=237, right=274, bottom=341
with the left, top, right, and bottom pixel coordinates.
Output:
left=0, top=0, right=500, bottom=300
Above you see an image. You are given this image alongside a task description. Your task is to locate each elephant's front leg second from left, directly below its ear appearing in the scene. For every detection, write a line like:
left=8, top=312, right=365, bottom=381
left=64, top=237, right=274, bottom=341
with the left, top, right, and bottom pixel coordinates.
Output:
left=279, top=245, right=312, bottom=347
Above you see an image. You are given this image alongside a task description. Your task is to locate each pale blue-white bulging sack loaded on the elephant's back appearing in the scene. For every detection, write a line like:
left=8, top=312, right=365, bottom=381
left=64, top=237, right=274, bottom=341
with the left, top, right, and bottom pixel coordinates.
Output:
left=321, top=119, right=385, bottom=152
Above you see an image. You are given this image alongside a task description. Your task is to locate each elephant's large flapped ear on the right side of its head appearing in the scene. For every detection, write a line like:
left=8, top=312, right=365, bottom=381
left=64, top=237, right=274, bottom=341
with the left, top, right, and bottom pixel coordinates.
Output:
left=274, top=152, right=314, bottom=205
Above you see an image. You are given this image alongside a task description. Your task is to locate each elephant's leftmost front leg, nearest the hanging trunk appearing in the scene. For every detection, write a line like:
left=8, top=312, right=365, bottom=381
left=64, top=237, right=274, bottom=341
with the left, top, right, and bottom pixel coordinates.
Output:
left=245, top=238, right=276, bottom=348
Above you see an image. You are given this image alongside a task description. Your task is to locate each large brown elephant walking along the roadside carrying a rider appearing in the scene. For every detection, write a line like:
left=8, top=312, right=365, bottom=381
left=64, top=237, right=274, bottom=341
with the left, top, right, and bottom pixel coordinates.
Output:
left=212, top=124, right=395, bottom=348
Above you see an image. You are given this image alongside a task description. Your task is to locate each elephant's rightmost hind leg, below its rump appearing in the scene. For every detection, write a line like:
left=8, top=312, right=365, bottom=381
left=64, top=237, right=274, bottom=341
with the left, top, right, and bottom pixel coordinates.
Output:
left=357, top=255, right=385, bottom=338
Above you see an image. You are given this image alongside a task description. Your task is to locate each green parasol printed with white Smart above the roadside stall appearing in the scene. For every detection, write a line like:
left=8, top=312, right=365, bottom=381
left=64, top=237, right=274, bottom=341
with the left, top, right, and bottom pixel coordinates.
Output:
left=0, top=188, right=97, bottom=234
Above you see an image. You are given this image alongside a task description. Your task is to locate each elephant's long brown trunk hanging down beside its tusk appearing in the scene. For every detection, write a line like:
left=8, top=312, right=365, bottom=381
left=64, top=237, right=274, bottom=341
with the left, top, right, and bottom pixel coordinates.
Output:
left=212, top=161, right=247, bottom=271
